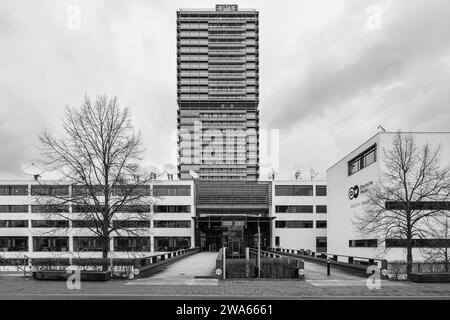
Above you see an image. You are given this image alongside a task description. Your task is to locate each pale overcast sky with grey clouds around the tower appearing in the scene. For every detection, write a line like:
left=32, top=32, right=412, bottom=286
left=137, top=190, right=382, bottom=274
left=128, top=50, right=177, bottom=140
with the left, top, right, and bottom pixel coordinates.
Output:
left=0, top=0, right=450, bottom=180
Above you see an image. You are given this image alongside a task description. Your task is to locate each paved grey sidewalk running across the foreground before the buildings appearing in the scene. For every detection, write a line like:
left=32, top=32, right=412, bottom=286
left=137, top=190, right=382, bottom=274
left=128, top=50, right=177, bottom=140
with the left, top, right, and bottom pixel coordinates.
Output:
left=0, top=277, right=450, bottom=299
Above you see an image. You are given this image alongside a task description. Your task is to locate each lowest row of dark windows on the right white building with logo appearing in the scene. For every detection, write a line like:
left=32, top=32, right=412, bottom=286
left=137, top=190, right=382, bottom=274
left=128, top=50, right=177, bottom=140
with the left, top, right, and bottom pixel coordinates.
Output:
left=348, top=239, right=450, bottom=248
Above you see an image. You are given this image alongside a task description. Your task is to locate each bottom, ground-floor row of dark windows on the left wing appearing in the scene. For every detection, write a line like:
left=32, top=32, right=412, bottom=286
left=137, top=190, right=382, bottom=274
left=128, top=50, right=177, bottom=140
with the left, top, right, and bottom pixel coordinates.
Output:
left=0, top=237, right=191, bottom=252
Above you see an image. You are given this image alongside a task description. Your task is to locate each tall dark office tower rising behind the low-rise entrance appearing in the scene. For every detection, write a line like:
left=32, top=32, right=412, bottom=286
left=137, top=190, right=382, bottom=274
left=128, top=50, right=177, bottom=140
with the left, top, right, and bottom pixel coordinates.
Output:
left=177, top=5, right=259, bottom=181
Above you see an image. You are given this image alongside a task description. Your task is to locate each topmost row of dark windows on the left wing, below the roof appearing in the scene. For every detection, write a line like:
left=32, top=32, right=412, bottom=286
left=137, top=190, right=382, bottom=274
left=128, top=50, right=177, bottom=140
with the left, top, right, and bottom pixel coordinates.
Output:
left=0, top=185, right=191, bottom=197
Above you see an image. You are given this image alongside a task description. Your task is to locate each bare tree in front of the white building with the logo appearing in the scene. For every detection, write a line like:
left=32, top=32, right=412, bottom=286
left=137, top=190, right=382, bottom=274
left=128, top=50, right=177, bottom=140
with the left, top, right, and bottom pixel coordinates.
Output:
left=353, top=132, right=450, bottom=274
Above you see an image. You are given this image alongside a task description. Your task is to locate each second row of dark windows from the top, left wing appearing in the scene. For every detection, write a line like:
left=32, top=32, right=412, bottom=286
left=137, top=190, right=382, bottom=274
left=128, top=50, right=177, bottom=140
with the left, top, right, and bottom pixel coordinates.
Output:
left=0, top=205, right=191, bottom=213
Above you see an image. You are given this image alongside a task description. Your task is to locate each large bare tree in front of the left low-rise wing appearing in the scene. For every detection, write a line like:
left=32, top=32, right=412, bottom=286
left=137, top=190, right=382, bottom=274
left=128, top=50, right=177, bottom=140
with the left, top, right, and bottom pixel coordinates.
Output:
left=35, top=95, right=152, bottom=268
